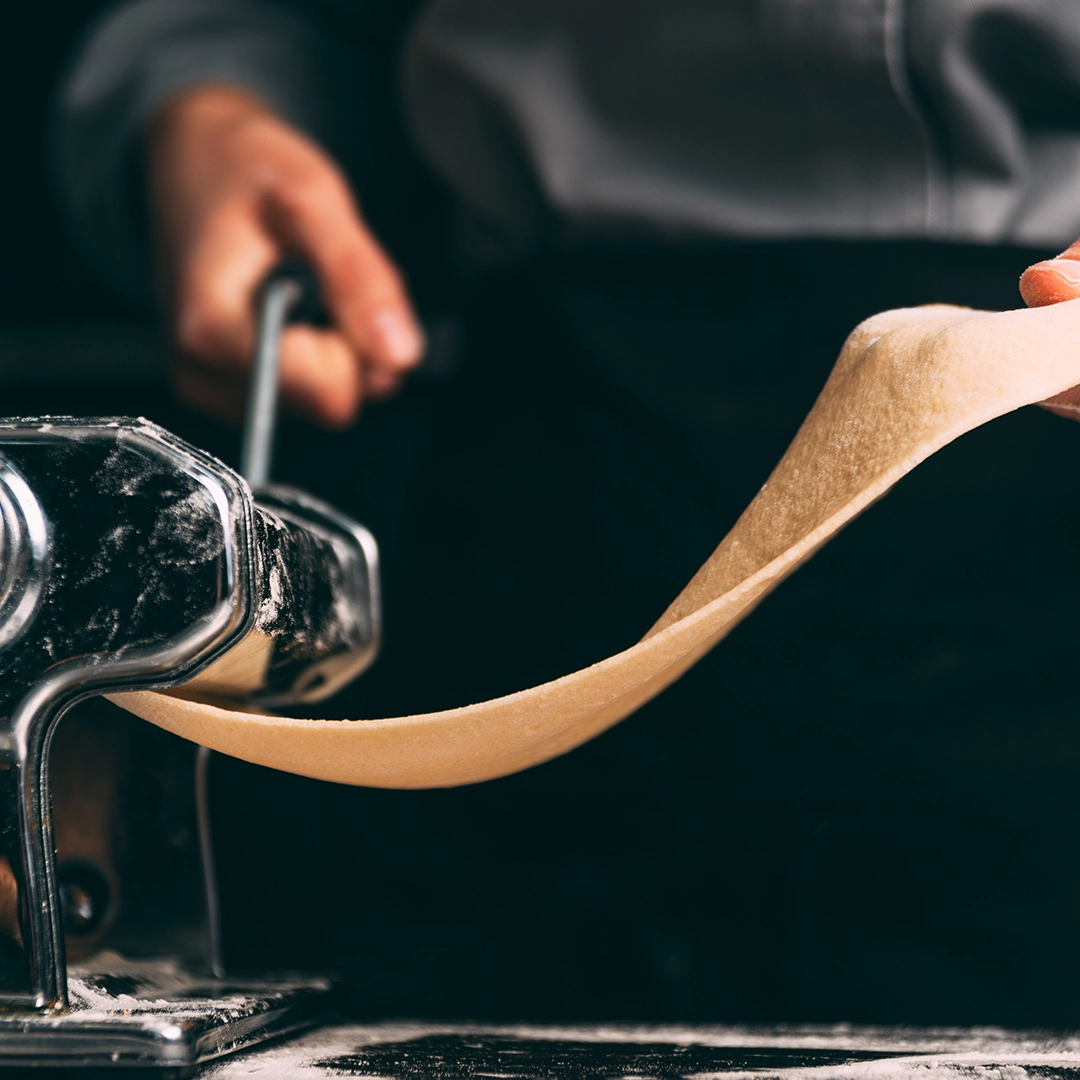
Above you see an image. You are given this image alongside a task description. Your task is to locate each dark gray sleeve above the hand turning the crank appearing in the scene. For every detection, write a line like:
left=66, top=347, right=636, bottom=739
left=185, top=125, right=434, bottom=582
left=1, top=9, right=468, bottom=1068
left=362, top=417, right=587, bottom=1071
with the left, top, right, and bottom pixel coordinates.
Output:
left=52, top=0, right=342, bottom=300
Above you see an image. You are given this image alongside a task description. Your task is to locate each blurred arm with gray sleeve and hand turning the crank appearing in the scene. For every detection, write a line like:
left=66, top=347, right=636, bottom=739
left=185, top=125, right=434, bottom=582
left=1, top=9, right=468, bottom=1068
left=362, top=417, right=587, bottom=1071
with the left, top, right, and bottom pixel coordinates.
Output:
left=54, top=0, right=422, bottom=426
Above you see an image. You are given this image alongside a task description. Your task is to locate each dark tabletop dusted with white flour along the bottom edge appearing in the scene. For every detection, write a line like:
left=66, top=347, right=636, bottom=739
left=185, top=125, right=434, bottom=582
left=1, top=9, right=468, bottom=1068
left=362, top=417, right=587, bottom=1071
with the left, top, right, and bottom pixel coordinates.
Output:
left=192, top=1023, right=1080, bottom=1080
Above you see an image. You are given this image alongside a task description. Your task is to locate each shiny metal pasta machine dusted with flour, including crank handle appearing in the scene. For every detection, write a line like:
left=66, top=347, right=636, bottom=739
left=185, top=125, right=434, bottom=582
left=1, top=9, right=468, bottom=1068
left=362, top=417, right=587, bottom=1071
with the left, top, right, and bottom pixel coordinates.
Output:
left=0, top=267, right=380, bottom=1069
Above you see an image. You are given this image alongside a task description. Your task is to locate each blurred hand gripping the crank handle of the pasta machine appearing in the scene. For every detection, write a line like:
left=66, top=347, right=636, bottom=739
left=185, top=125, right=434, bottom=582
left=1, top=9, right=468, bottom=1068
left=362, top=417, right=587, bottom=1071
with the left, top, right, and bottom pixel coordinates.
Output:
left=147, top=86, right=423, bottom=428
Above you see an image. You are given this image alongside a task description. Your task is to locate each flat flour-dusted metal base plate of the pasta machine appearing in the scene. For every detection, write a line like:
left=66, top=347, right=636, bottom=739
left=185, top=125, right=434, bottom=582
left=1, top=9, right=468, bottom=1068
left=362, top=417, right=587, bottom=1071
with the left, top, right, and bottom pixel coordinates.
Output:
left=0, top=953, right=333, bottom=1075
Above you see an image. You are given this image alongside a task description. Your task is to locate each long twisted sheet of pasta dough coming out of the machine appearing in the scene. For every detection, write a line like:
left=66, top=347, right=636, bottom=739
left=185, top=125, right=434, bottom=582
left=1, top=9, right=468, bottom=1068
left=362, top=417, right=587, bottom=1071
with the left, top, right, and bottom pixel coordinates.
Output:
left=113, top=300, right=1080, bottom=787
